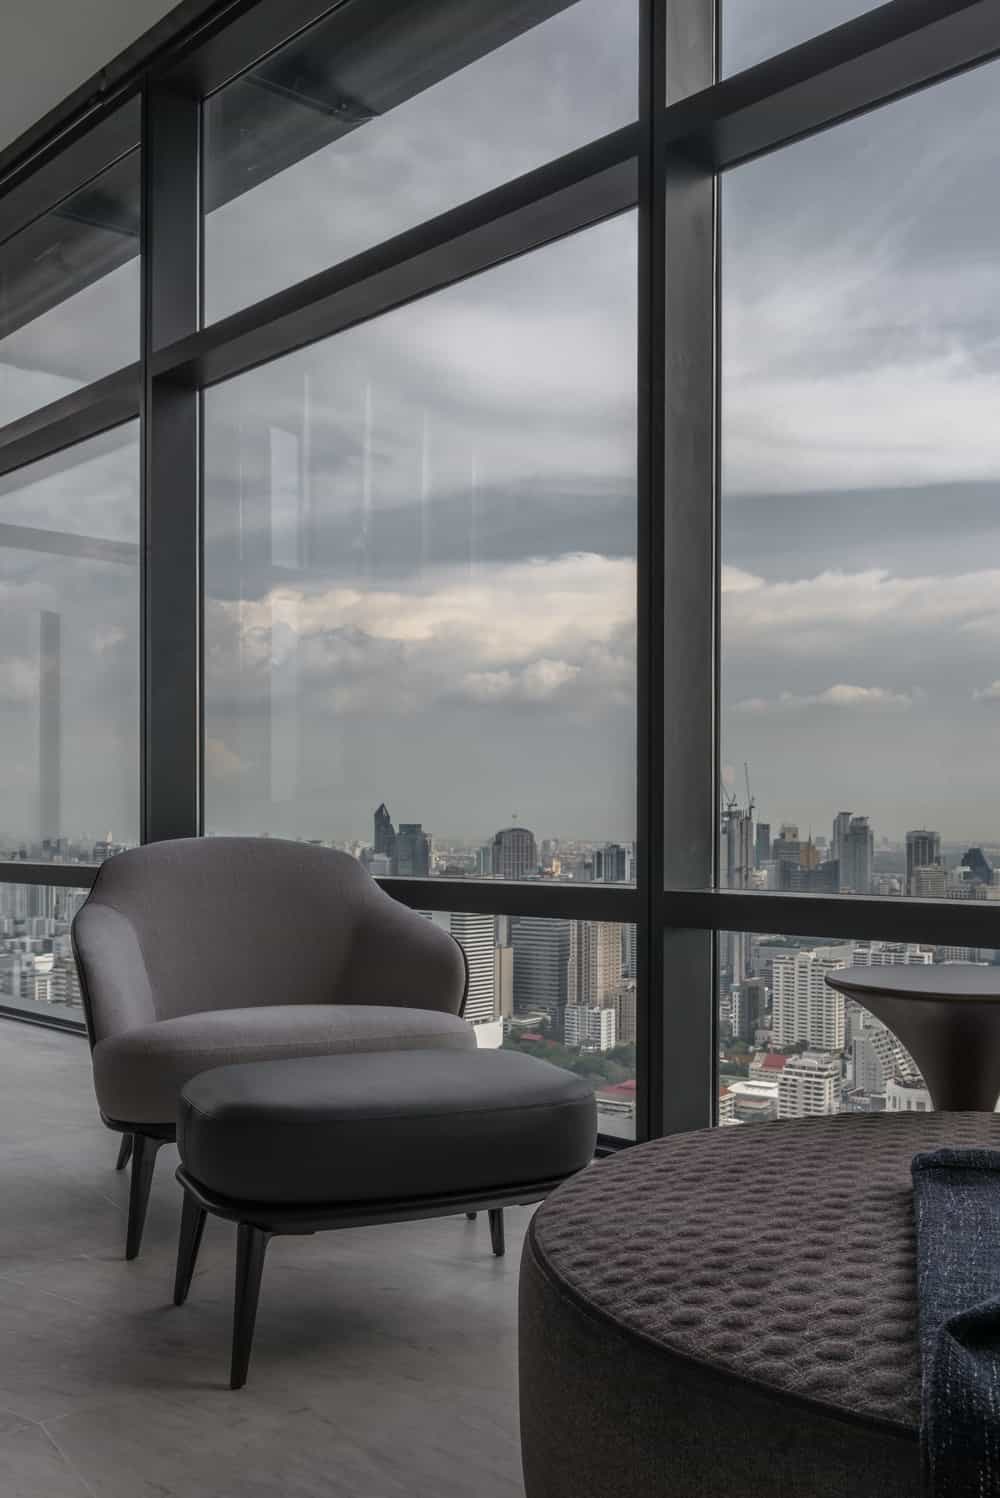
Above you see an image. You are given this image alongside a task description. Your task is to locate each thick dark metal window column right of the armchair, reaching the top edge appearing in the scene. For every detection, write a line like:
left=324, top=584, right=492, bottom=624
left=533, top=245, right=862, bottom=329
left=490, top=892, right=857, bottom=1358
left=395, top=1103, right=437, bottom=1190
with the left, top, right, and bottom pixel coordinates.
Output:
left=639, top=0, right=717, bottom=1137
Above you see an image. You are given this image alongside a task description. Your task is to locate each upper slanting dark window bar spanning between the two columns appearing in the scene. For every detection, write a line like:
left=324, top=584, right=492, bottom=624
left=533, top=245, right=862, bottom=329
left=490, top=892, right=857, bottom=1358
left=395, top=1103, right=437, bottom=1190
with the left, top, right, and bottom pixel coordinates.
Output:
left=153, top=126, right=638, bottom=388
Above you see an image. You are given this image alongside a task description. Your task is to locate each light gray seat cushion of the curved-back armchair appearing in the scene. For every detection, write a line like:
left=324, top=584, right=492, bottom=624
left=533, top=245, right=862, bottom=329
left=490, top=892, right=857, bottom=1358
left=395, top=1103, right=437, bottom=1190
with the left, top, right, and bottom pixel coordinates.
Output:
left=94, top=1004, right=476, bottom=1125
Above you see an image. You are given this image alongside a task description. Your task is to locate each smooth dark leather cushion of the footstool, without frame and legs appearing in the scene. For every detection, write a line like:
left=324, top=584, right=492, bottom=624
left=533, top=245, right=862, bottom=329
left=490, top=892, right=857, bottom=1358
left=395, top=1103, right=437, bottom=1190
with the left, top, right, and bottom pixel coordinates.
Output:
left=177, top=1050, right=596, bottom=1206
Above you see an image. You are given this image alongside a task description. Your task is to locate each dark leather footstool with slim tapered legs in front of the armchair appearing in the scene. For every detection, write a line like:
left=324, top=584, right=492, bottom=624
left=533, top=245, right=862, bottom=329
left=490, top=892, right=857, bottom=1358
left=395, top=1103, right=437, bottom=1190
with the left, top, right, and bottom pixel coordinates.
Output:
left=174, top=1050, right=596, bottom=1389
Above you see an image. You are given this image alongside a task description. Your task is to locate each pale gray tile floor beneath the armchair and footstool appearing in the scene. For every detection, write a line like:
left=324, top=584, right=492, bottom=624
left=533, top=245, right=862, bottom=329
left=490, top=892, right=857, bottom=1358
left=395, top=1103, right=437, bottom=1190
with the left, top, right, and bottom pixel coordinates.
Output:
left=0, top=1020, right=530, bottom=1498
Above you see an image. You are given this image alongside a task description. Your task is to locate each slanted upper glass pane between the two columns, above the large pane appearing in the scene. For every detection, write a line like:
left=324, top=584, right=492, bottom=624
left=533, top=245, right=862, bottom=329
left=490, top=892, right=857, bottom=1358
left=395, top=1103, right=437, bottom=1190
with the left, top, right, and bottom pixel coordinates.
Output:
left=205, top=0, right=639, bottom=322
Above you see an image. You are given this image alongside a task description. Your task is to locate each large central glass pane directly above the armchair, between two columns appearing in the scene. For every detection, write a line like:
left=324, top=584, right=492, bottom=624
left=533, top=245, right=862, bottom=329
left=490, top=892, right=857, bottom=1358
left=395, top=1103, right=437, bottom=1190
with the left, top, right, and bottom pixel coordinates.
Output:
left=205, top=214, right=636, bottom=878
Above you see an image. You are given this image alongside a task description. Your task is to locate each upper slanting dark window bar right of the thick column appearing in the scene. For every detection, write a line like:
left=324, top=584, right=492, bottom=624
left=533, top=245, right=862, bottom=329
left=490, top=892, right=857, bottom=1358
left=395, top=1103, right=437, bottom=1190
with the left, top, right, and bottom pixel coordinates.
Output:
left=665, top=0, right=1000, bottom=171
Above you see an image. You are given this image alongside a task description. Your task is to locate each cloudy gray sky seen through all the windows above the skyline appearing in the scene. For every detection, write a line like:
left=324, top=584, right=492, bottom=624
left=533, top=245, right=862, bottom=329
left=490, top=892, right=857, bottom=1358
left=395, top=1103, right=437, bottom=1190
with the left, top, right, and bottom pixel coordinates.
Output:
left=0, top=0, right=1000, bottom=840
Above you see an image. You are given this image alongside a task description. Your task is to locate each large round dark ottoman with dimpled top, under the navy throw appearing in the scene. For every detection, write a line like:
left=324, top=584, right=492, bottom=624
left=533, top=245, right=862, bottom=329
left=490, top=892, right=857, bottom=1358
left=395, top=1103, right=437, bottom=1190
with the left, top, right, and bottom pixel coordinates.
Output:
left=519, top=1113, right=1000, bottom=1498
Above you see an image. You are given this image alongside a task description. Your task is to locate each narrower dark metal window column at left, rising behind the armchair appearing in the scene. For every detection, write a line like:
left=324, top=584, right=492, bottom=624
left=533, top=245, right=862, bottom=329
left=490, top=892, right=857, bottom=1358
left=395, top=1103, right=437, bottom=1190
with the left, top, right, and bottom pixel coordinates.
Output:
left=142, top=84, right=201, bottom=842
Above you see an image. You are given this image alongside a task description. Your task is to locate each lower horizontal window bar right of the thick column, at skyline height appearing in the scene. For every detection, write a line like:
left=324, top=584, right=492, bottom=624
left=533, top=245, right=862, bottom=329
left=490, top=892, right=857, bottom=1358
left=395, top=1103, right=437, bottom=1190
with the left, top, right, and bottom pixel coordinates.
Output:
left=663, top=890, right=1000, bottom=947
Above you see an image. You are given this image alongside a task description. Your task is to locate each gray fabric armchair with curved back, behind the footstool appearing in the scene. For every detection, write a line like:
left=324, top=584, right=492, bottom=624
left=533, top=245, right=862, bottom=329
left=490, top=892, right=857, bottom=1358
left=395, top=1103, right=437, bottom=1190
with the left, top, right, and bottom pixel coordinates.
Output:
left=73, top=837, right=476, bottom=1258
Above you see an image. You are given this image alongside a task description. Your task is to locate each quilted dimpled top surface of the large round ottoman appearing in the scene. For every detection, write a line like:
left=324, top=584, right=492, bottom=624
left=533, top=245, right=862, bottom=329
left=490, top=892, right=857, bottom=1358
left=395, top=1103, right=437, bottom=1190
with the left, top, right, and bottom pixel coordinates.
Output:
left=531, top=1113, right=1000, bottom=1432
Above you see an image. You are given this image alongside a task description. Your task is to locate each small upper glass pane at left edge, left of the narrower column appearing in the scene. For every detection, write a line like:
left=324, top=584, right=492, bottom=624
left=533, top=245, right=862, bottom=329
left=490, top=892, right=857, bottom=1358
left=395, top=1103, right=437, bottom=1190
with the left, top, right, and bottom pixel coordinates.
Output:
left=0, top=151, right=139, bottom=425
